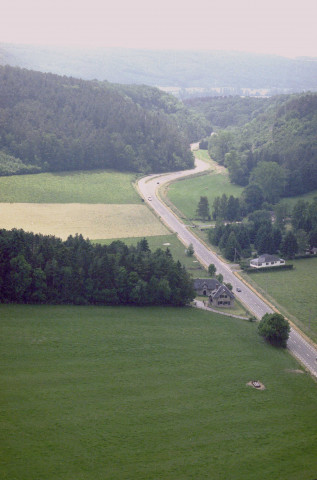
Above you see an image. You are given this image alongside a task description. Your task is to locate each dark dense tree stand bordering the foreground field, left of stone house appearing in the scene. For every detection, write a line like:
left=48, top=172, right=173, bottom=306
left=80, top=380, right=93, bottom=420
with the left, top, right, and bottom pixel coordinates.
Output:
left=0, top=230, right=195, bottom=306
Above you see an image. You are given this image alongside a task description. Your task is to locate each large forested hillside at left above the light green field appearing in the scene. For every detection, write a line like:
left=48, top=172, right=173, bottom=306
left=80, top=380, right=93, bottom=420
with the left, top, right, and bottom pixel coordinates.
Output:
left=0, top=66, right=210, bottom=175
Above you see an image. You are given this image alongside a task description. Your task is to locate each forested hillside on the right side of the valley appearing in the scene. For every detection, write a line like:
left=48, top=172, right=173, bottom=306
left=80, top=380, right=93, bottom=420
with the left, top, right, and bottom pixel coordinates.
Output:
left=198, top=93, right=317, bottom=197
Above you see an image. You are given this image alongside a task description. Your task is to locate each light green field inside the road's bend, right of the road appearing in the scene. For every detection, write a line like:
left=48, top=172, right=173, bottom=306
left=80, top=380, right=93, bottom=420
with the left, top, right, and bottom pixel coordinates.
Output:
left=166, top=150, right=243, bottom=219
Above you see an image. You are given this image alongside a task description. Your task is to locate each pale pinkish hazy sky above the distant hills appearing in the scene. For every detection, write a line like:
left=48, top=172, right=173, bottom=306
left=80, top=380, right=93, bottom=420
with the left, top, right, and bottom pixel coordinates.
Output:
left=0, top=0, right=317, bottom=57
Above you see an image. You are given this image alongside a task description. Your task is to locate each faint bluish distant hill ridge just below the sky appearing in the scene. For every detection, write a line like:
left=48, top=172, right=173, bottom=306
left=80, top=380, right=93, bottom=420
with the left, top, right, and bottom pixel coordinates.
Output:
left=0, top=43, right=317, bottom=98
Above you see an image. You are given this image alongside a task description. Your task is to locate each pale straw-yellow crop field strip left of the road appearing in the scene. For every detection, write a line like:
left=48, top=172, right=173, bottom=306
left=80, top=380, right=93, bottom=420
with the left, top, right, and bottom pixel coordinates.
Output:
left=0, top=203, right=170, bottom=240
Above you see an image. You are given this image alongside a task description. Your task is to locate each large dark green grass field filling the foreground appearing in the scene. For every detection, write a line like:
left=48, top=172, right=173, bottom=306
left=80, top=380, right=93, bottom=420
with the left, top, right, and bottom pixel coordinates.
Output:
left=0, top=305, right=317, bottom=480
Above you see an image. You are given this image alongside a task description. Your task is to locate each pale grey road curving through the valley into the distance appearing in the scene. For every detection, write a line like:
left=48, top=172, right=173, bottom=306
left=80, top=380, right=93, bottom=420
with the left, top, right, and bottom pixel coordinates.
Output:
left=138, top=148, right=317, bottom=377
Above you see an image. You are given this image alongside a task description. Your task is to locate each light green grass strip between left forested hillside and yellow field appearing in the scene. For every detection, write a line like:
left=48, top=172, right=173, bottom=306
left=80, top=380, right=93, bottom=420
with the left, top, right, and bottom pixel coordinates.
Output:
left=0, top=170, right=141, bottom=204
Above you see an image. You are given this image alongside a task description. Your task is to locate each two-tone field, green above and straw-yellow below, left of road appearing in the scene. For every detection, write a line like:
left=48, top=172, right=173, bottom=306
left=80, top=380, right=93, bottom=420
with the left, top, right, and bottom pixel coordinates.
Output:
left=0, top=171, right=169, bottom=239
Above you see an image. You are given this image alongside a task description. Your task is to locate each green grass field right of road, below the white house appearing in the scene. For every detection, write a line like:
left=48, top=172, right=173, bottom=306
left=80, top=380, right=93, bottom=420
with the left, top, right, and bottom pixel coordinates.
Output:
left=244, top=258, right=317, bottom=342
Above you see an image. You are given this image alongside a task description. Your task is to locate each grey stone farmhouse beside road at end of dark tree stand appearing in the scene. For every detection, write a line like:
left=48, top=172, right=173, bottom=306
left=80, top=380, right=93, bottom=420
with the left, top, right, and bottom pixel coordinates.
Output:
left=194, top=278, right=234, bottom=307
